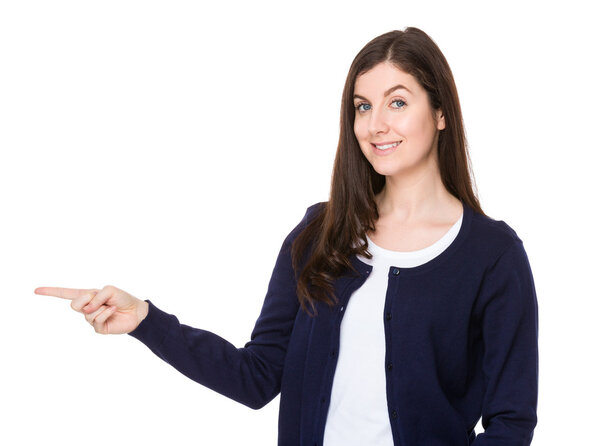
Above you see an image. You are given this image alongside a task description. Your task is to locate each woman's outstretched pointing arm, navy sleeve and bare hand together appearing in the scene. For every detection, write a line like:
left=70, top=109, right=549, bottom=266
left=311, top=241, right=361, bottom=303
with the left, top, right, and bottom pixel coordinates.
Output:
left=36, top=205, right=315, bottom=409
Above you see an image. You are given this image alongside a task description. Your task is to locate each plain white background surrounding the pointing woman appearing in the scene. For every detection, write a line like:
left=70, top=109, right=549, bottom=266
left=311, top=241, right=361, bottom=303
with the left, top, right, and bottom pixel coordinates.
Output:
left=0, top=0, right=600, bottom=446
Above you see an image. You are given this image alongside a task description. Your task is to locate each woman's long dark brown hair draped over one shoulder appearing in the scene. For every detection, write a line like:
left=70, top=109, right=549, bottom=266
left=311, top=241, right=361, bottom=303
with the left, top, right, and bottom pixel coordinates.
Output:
left=292, top=28, right=485, bottom=315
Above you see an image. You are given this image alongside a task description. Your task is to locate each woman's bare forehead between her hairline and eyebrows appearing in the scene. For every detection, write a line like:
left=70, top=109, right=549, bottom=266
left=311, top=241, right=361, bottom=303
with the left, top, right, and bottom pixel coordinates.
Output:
left=354, top=62, right=423, bottom=97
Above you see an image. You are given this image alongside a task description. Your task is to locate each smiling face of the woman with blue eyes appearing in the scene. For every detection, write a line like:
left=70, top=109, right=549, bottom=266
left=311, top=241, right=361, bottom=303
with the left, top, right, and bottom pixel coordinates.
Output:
left=354, top=62, right=445, bottom=181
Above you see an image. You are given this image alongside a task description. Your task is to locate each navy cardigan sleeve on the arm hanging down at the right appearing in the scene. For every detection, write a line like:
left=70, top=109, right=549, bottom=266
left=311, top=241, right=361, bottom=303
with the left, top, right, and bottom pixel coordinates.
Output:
left=472, top=239, right=538, bottom=446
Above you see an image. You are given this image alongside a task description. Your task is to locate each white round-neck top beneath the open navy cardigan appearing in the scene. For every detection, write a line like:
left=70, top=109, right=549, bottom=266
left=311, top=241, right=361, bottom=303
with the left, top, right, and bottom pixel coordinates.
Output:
left=323, top=211, right=462, bottom=446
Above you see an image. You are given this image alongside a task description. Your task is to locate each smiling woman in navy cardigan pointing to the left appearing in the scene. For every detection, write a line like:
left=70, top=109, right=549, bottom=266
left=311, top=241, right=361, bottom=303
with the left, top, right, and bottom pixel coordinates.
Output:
left=35, top=28, right=538, bottom=446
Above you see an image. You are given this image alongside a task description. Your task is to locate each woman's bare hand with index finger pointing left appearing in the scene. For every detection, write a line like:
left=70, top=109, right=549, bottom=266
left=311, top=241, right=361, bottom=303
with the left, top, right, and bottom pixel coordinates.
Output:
left=34, top=285, right=148, bottom=334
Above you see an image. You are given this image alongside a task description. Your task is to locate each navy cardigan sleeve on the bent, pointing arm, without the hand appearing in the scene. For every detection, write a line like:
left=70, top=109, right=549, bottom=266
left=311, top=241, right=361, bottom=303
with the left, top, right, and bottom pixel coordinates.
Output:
left=129, top=205, right=315, bottom=409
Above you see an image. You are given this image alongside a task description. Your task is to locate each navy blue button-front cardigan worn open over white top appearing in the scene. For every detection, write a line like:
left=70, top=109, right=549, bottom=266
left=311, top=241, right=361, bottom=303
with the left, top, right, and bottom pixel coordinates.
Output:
left=130, top=203, right=538, bottom=446
